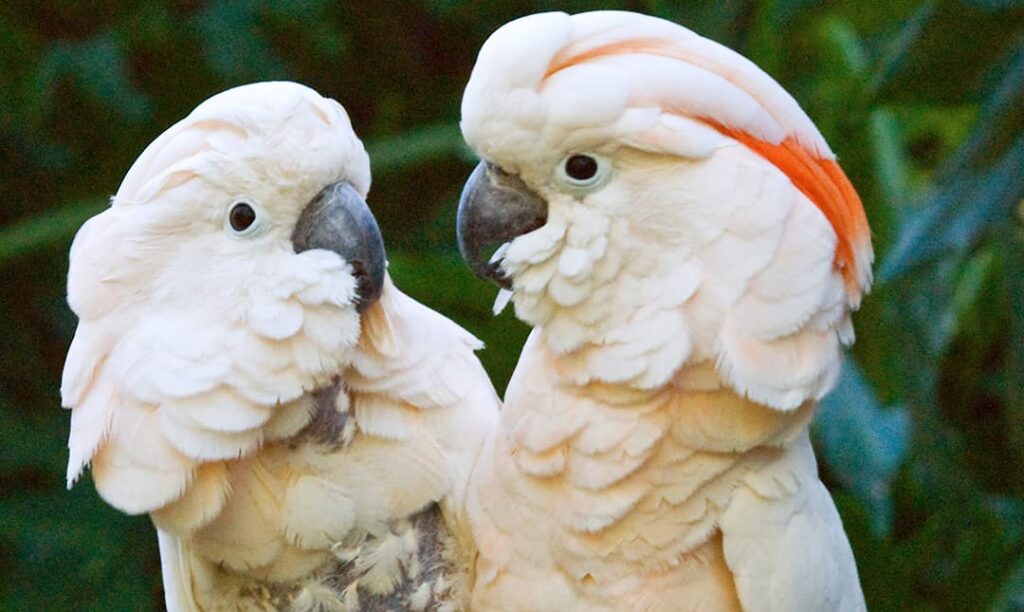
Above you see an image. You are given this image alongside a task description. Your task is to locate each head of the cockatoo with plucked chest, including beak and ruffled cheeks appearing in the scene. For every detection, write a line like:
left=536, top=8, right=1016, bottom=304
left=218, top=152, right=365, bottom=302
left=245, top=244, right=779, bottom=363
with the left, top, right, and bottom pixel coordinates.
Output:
left=61, top=82, right=386, bottom=512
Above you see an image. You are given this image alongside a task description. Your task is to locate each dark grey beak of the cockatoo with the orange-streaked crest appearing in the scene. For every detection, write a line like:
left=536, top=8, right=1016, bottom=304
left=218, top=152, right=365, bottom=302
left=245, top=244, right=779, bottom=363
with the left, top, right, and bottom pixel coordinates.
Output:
left=457, top=162, right=548, bottom=289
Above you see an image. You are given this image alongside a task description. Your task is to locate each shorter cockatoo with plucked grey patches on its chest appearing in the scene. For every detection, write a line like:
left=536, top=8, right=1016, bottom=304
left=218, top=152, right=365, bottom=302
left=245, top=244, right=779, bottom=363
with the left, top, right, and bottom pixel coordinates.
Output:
left=61, top=82, right=499, bottom=611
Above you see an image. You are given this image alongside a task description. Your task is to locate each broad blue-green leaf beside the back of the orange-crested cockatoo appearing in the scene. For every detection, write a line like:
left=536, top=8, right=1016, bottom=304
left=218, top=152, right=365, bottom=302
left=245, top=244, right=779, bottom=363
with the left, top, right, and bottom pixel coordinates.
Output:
left=814, top=359, right=910, bottom=536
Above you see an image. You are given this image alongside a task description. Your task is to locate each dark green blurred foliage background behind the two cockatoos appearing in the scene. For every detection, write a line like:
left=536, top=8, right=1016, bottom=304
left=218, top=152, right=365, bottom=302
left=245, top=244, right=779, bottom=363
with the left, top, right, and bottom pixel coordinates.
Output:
left=0, top=0, right=1024, bottom=611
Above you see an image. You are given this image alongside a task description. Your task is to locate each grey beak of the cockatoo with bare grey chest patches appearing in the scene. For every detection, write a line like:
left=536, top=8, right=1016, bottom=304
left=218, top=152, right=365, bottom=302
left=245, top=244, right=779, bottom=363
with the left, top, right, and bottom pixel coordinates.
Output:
left=292, top=181, right=387, bottom=312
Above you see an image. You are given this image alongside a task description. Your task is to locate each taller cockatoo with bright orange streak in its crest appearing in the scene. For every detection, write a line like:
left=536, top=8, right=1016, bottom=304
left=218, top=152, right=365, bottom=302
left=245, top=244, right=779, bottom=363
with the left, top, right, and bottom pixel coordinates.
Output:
left=458, top=12, right=872, bottom=611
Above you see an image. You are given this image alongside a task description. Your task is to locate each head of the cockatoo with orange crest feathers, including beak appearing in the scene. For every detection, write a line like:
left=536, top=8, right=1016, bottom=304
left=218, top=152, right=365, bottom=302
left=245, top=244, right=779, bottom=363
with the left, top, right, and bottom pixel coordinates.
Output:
left=458, top=11, right=872, bottom=405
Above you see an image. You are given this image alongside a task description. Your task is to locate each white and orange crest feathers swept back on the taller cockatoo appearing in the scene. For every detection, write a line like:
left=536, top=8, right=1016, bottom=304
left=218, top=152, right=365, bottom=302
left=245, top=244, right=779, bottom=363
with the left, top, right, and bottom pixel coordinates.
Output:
left=463, top=11, right=872, bottom=306
